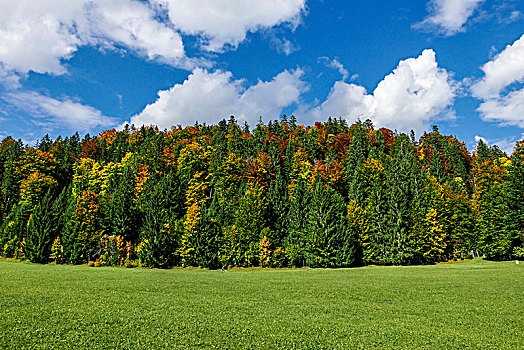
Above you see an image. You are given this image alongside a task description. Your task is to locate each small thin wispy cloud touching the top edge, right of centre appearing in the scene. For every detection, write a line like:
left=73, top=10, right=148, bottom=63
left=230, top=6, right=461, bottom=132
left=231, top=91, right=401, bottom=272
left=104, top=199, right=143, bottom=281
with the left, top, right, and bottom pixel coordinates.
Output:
left=414, top=0, right=484, bottom=36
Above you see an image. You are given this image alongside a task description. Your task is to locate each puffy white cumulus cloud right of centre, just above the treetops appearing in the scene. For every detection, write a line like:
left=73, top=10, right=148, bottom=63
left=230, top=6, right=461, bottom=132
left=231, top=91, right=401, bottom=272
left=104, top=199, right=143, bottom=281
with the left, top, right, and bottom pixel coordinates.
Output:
left=304, top=50, right=456, bottom=132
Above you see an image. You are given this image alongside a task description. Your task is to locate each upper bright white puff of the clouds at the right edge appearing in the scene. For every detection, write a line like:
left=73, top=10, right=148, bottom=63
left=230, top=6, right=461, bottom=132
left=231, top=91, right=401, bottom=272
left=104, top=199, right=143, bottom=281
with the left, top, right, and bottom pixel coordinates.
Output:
left=471, top=35, right=524, bottom=99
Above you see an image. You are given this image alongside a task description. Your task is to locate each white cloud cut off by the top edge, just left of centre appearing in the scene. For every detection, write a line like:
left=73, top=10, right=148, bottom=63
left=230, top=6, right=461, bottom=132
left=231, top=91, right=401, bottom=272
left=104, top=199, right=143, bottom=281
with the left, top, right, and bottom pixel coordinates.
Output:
left=152, top=0, right=306, bottom=52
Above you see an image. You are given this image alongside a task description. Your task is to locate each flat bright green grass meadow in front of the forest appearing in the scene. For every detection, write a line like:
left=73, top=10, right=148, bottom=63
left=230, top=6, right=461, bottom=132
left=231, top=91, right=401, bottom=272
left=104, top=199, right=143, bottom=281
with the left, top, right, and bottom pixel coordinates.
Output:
left=0, top=260, right=524, bottom=349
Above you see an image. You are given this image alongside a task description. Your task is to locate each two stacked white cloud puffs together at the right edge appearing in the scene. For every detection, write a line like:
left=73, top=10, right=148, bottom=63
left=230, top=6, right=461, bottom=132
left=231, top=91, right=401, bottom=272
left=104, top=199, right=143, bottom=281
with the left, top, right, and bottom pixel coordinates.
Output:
left=471, top=35, right=524, bottom=128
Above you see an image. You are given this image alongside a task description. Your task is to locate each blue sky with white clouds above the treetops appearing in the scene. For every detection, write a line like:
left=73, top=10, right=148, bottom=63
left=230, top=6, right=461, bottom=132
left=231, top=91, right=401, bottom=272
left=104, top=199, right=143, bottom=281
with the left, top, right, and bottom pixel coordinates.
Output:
left=0, top=0, right=524, bottom=152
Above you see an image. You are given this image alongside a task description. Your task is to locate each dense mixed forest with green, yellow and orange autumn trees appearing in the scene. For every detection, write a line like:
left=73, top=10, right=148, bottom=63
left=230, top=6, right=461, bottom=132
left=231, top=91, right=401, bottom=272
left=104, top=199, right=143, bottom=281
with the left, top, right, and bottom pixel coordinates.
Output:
left=0, top=116, right=524, bottom=269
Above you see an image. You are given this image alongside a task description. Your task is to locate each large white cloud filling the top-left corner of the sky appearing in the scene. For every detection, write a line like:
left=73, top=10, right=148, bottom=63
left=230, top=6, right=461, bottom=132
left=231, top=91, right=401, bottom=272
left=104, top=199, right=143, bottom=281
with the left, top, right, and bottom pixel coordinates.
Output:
left=0, top=0, right=184, bottom=74
